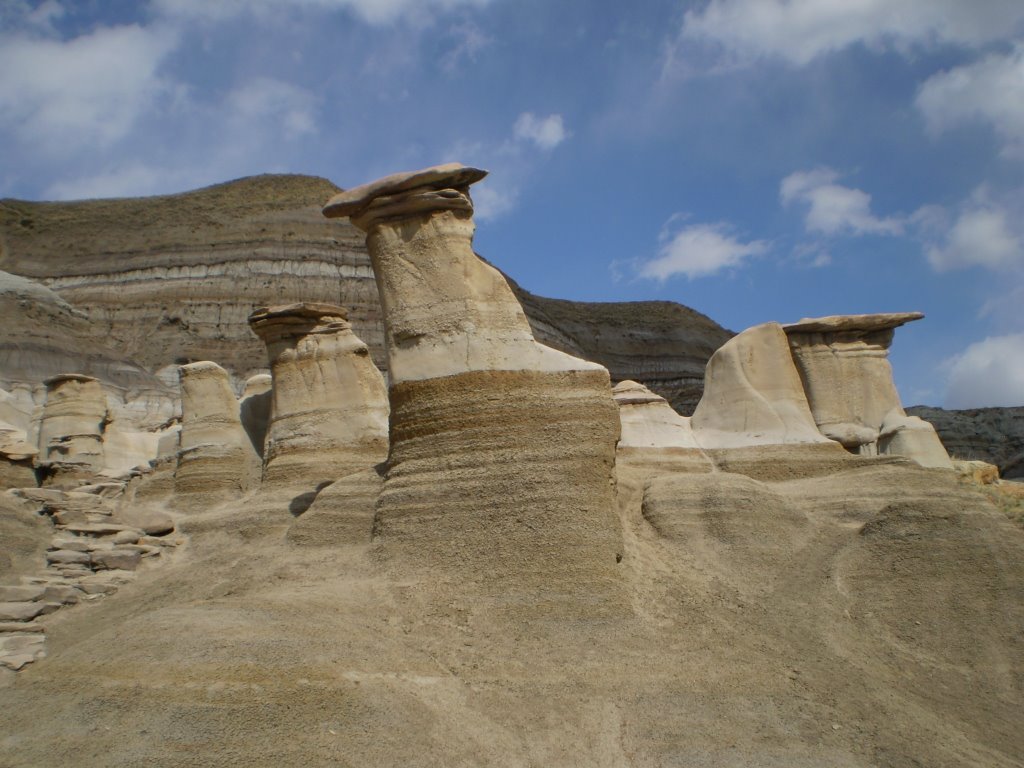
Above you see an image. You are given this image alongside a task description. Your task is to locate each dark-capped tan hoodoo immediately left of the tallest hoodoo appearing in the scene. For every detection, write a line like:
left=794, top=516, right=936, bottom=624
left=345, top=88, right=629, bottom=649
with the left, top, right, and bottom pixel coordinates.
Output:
left=249, top=303, right=388, bottom=488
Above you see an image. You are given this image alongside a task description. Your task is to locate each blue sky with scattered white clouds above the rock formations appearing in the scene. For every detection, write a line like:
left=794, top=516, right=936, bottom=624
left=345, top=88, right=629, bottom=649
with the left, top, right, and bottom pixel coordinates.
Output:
left=0, top=0, right=1024, bottom=408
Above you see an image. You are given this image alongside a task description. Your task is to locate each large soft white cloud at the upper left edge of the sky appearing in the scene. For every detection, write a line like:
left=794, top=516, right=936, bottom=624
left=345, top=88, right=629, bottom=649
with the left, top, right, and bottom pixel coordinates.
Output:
left=0, top=25, right=177, bottom=150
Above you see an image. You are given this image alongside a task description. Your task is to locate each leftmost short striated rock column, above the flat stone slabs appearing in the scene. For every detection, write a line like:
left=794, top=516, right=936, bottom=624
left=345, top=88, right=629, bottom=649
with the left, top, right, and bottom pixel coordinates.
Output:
left=39, top=374, right=108, bottom=487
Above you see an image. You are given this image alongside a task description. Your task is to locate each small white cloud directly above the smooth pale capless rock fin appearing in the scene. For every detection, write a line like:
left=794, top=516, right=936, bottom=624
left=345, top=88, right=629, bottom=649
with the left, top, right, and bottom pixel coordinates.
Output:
left=639, top=217, right=768, bottom=282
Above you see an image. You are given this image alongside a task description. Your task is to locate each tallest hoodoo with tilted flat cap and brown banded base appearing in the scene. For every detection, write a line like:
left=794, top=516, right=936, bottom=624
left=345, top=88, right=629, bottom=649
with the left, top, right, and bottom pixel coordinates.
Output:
left=325, top=164, right=628, bottom=617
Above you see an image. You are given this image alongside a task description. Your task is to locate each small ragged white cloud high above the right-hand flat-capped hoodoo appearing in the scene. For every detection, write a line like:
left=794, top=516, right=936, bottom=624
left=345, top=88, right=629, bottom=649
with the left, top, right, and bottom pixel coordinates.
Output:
left=779, top=168, right=903, bottom=234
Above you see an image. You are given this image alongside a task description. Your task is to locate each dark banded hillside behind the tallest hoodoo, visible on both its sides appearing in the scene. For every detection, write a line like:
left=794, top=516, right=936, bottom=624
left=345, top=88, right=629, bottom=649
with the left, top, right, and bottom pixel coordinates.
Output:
left=0, top=175, right=731, bottom=413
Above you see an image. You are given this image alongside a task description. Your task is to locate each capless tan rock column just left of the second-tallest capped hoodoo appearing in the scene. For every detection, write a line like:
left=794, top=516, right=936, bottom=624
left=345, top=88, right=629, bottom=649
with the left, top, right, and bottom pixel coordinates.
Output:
left=174, top=361, right=260, bottom=495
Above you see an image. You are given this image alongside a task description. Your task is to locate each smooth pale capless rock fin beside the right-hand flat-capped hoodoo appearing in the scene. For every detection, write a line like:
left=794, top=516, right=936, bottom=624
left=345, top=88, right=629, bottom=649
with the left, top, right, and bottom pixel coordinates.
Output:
left=690, top=323, right=828, bottom=449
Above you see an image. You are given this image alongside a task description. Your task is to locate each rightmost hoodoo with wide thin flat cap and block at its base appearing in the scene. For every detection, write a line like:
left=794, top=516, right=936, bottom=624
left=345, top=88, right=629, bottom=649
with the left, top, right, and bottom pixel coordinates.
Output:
left=784, top=312, right=952, bottom=468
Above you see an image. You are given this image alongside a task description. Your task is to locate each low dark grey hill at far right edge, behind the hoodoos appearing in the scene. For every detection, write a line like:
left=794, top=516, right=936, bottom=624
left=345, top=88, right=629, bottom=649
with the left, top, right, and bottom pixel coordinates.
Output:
left=906, top=406, right=1024, bottom=479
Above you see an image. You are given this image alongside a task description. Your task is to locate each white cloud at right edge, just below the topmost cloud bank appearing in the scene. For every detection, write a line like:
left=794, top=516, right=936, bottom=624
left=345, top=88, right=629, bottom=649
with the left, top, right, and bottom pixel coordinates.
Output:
left=915, top=44, right=1024, bottom=158
